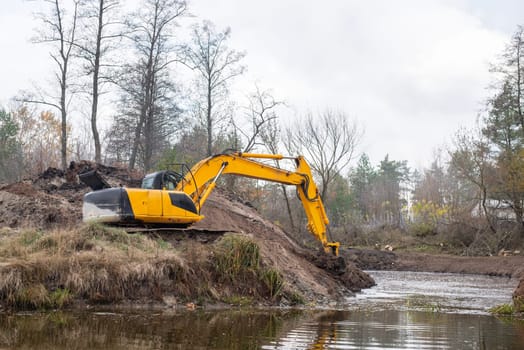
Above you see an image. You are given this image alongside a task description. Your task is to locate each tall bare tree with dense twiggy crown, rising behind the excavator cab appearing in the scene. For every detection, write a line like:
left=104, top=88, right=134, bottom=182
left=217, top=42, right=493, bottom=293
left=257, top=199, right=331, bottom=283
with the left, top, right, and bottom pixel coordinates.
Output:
left=122, top=0, right=187, bottom=170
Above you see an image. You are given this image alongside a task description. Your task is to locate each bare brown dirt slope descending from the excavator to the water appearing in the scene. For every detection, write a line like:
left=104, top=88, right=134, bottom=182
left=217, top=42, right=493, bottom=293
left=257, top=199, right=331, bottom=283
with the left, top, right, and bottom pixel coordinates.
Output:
left=194, top=191, right=375, bottom=301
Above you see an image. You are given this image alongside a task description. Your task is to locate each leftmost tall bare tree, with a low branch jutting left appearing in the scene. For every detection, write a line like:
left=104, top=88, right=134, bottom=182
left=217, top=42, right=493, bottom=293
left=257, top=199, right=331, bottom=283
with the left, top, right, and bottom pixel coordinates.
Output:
left=23, top=0, right=78, bottom=169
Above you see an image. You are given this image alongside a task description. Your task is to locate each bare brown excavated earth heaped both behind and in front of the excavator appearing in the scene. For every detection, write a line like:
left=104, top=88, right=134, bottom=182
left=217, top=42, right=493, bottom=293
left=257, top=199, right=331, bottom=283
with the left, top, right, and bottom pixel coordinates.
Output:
left=0, top=161, right=374, bottom=304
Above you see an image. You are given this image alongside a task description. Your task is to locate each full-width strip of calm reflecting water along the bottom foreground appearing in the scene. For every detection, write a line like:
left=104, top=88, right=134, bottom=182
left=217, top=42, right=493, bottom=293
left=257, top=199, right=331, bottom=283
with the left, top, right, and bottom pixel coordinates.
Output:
left=0, top=310, right=524, bottom=349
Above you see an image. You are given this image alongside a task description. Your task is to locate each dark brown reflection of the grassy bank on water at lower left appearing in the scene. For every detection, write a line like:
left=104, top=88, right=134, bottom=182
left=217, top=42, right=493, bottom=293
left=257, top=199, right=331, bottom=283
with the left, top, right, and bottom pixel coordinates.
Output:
left=0, top=311, right=302, bottom=349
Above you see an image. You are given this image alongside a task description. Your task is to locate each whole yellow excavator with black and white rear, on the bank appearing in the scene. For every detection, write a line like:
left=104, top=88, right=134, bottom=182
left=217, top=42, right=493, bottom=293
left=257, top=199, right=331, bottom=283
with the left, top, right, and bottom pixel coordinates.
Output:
left=79, top=152, right=340, bottom=255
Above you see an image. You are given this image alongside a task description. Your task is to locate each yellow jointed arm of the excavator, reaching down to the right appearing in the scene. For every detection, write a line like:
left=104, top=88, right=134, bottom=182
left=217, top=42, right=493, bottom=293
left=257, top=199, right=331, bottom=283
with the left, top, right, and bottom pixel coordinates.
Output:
left=176, top=153, right=340, bottom=255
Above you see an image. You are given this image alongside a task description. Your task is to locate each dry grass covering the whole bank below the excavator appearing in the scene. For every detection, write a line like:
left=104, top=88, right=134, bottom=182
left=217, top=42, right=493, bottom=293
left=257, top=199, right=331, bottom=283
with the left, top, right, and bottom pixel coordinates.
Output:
left=0, top=225, right=290, bottom=309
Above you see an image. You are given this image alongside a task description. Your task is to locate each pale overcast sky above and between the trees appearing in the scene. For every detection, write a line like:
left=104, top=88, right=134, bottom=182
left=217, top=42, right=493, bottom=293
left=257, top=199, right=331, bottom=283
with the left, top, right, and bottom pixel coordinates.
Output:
left=0, top=0, right=524, bottom=167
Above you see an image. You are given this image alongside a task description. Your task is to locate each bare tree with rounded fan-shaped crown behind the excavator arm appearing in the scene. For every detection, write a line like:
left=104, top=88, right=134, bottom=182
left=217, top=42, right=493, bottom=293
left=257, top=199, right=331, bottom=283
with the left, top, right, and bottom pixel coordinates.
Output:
left=286, top=110, right=361, bottom=198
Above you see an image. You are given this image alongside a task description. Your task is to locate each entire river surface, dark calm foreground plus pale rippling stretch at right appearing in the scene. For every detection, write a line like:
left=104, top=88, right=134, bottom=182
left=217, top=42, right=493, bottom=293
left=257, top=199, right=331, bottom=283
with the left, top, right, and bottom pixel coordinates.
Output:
left=0, top=272, right=524, bottom=350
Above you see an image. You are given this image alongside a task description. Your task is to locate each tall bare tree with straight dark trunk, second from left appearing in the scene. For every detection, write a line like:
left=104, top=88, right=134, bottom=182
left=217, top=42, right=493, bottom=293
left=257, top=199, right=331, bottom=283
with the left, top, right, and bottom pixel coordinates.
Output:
left=77, top=0, right=121, bottom=163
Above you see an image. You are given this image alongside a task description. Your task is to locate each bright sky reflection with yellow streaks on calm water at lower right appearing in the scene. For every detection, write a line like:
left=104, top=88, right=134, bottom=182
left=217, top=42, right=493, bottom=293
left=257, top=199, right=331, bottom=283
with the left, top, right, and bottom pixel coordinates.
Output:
left=263, top=311, right=524, bottom=349
